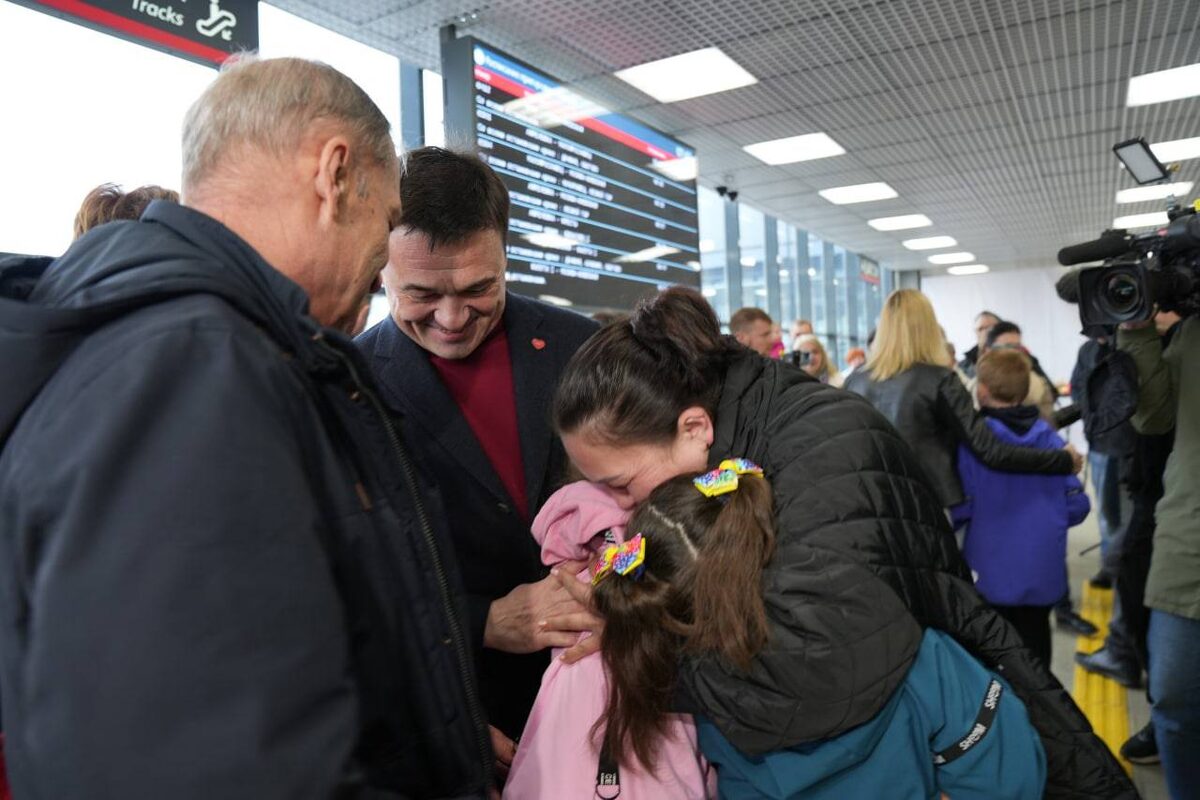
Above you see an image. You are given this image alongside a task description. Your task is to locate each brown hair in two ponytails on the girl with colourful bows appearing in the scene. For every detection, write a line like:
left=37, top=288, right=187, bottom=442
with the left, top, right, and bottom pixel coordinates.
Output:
left=593, top=475, right=775, bottom=769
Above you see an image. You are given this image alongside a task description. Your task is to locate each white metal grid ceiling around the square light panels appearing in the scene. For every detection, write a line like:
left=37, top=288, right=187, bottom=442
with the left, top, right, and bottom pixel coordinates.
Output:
left=276, top=0, right=1200, bottom=269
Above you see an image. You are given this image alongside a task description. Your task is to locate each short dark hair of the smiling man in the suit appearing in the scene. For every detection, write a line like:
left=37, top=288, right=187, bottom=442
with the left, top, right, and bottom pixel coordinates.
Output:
left=400, top=148, right=509, bottom=249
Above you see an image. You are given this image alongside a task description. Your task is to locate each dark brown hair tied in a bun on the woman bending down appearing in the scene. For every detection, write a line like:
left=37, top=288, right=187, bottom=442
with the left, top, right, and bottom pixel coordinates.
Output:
left=552, top=287, right=742, bottom=444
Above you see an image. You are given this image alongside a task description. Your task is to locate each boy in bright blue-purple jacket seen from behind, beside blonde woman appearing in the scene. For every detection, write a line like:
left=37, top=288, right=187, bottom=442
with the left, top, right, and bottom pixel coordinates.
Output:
left=952, top=349, right=1091, bottom=664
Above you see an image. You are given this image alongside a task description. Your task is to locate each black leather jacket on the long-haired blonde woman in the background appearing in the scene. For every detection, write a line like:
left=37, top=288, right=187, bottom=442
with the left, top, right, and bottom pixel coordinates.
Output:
left=846, top=363, right=1074, bottom=507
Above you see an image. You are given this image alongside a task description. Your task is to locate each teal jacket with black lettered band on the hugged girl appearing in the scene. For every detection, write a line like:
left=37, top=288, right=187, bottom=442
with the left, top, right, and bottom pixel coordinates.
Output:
left=696, top=630, right=1046, bottom=800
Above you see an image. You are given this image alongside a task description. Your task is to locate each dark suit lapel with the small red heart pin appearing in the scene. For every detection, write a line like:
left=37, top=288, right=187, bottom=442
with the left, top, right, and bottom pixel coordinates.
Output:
left=504, top=293, right=562, bottom=513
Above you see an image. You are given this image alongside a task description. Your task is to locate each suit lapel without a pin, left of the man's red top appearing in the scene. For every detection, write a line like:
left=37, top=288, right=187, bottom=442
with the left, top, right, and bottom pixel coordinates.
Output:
left=372, top=319, right=508, bottom=499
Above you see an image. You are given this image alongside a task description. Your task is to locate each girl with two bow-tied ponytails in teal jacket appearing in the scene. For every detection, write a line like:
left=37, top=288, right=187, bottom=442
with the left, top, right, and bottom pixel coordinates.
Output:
left=593, top=458, right=1045, bottom=800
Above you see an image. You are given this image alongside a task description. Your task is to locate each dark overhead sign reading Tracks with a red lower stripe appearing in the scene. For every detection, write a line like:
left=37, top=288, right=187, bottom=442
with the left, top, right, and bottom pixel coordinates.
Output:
left=22, top=0, right=258, bottom=66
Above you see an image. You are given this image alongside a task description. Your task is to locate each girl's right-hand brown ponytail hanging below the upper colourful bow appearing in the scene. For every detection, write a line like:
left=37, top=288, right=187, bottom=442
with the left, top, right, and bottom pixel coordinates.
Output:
left=688, top=475, right=775, bottom=670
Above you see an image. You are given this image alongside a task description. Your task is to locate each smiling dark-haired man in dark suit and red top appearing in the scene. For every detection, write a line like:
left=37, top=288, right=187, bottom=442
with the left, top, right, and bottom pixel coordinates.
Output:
left=358, top=148, right=596, bottom=753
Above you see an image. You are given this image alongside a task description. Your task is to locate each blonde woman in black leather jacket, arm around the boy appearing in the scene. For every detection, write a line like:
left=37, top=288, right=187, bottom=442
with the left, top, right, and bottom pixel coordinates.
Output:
left=846, top=289, right=1082, bottom=509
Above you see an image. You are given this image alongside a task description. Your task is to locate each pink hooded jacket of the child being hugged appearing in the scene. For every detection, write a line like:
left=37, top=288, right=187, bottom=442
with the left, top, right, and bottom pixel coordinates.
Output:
left=503, top=481, right=716, bottom=800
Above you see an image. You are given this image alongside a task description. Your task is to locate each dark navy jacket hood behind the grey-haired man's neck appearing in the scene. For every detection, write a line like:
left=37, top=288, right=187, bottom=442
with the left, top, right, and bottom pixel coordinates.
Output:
left=0, top=200, right=319, bottom=443
